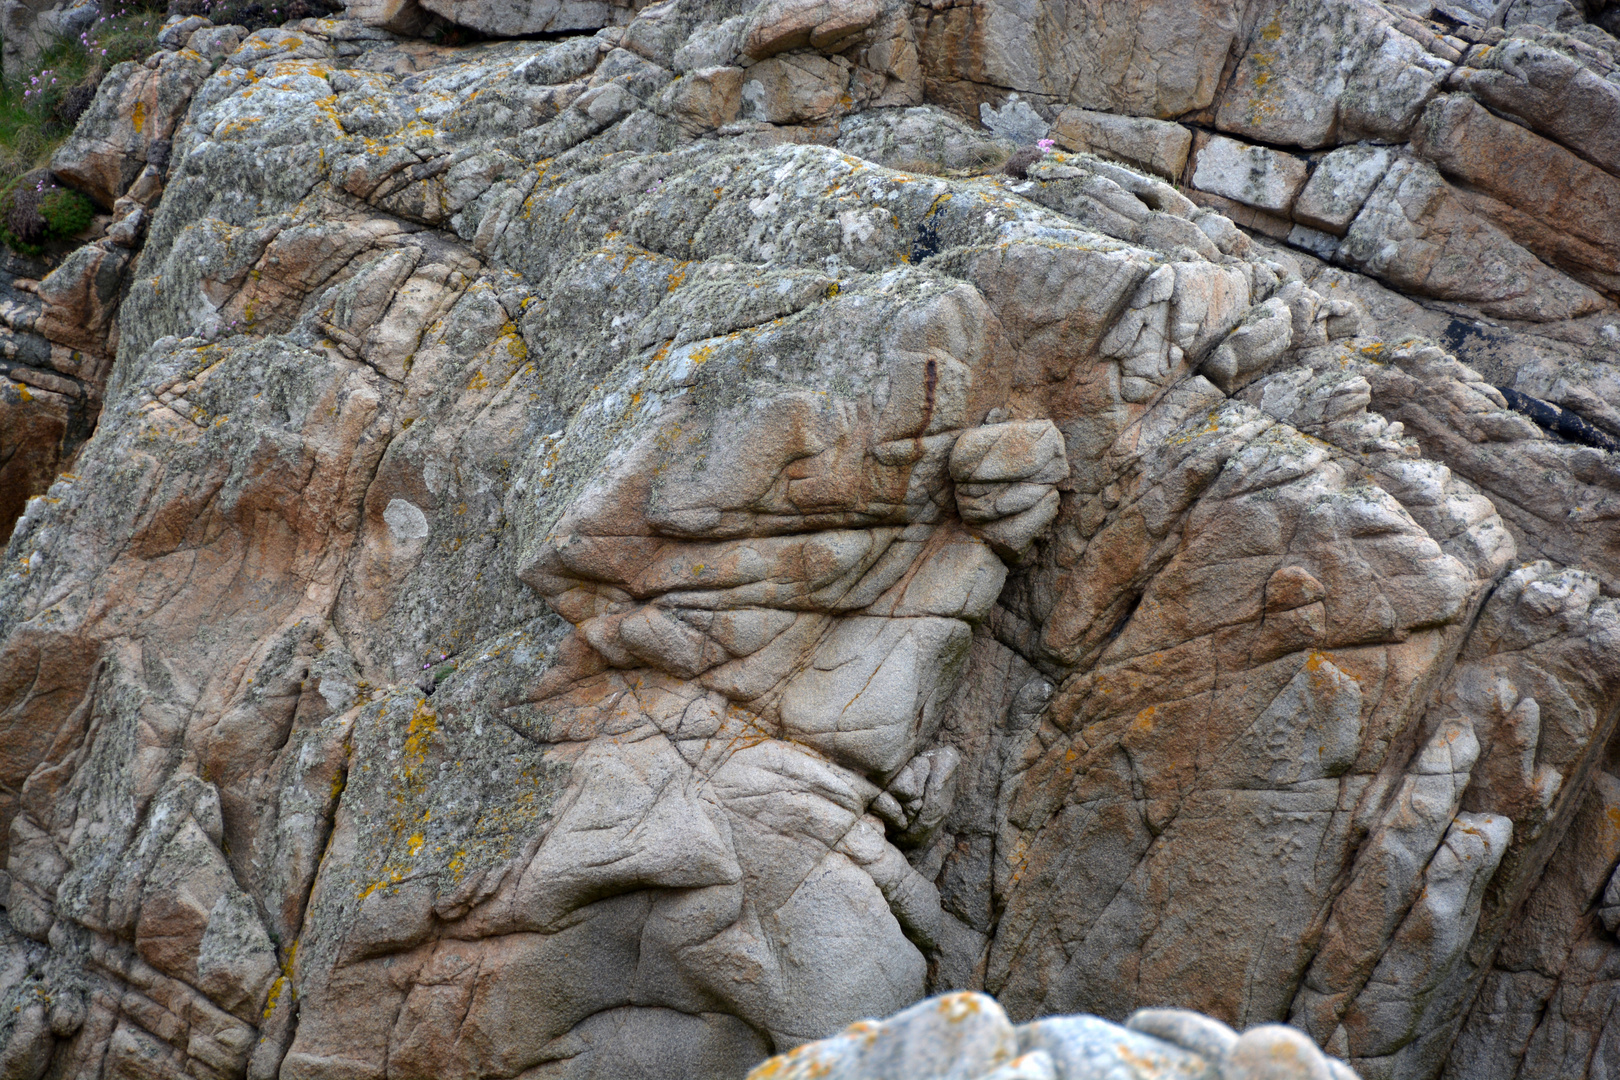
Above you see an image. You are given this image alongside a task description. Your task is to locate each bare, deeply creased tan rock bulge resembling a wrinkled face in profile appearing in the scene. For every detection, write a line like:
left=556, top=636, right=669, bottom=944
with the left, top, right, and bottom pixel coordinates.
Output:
left=285, top=270, right=1068, bottom=1077
